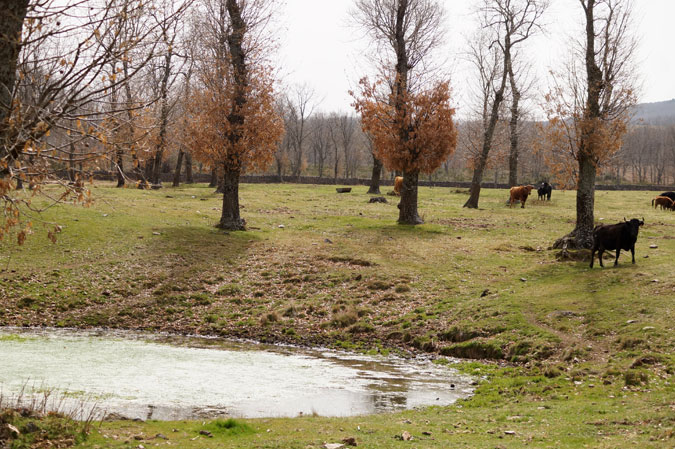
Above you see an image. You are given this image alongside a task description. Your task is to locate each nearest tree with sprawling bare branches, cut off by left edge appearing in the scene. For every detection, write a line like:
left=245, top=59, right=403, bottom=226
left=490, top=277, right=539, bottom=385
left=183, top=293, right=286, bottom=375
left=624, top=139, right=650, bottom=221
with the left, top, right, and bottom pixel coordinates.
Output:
left=0, top=0, right=177, bottom=241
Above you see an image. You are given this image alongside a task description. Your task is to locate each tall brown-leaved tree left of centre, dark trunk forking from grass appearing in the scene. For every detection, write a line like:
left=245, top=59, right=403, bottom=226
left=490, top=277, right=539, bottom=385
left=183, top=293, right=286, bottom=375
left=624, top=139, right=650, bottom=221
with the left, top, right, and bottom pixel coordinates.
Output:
left=189, top=0, right=284, bottom=230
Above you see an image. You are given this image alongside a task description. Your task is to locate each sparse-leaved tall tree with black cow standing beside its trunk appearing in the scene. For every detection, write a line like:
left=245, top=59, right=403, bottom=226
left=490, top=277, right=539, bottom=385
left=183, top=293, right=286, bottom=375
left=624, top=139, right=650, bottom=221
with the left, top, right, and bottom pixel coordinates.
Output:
left=548, top=0, right=637, bottom=248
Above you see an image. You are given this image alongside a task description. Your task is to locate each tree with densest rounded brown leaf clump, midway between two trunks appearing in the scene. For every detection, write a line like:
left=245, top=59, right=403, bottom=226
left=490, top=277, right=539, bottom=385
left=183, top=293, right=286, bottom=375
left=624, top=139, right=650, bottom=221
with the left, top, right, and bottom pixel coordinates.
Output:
left=352, top=0, right=457, bottom=225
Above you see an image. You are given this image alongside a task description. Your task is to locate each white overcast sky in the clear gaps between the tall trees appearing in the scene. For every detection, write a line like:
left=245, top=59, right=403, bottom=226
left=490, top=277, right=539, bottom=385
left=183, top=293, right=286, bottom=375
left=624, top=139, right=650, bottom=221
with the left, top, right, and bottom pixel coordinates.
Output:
left=279, top=0, right=675, bottom=114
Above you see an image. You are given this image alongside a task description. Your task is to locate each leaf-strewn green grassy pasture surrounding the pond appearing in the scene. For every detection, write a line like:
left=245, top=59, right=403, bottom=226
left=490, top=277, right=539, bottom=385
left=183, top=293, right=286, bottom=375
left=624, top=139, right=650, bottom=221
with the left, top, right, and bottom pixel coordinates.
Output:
left=0, top=184, right=675, bottom=448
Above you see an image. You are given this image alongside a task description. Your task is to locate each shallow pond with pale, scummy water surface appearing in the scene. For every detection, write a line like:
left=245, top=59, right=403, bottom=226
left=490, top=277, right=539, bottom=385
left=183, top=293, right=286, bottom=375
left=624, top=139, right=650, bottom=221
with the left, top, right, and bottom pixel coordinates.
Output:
left=0, top=328, right=472, bottom=420
